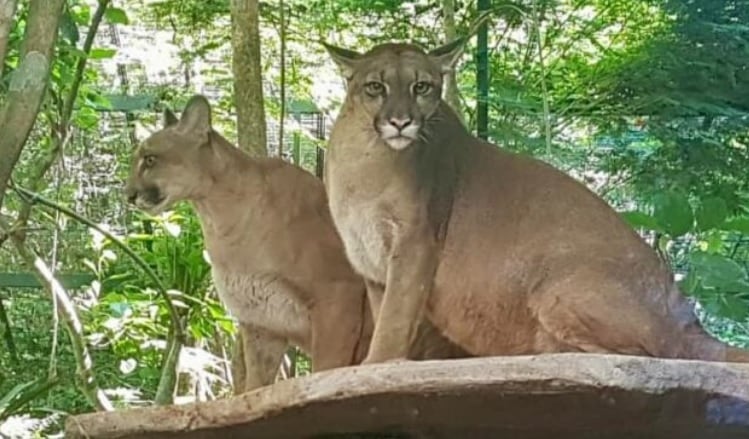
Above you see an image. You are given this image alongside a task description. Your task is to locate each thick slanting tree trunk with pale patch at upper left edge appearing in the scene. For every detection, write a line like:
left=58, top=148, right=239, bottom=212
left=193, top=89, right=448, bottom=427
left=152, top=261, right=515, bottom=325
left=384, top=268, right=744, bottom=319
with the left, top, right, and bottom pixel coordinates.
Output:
left=0, top=0, right=64, bottom=213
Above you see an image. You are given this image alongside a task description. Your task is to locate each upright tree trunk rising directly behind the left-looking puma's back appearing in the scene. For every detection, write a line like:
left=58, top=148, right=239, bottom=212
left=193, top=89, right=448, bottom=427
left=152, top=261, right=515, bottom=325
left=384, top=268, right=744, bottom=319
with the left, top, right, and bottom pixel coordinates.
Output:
left=231, top=0, right=268, bottom=156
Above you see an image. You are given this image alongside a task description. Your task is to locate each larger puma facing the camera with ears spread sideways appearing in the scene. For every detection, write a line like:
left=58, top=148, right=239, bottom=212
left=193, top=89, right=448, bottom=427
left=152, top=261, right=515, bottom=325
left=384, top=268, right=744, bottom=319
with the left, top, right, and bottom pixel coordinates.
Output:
left=325, top=39, right=749, bottom=363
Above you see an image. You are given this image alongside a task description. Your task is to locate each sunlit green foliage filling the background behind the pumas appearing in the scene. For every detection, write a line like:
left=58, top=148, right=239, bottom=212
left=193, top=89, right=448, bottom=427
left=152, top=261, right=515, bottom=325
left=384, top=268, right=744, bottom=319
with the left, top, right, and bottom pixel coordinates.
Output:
left=0, top=0, right=749, bottom=434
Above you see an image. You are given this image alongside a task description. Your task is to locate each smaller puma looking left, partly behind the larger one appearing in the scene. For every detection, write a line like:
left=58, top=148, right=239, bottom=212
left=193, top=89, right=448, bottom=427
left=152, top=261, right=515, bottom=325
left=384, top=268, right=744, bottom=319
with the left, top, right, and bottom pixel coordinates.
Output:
left=126, top=95, right=468, bottom=392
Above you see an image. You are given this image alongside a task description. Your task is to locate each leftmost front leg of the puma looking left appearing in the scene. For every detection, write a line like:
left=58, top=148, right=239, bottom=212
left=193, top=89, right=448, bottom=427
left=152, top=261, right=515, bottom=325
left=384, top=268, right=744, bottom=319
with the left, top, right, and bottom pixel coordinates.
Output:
left=232, top=323, right=288, bottom=395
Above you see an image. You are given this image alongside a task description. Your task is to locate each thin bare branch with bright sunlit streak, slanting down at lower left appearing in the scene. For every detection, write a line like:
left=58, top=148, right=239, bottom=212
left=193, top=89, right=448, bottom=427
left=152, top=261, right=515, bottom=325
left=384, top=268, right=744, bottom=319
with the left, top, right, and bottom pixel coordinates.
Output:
left=0, top=219, right=114, bottom=411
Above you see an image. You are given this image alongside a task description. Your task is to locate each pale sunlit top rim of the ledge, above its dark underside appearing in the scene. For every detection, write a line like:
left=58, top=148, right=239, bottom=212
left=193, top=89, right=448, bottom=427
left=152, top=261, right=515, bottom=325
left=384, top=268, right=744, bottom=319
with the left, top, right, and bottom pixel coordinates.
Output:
left=65, top=353, right=749, bottom=439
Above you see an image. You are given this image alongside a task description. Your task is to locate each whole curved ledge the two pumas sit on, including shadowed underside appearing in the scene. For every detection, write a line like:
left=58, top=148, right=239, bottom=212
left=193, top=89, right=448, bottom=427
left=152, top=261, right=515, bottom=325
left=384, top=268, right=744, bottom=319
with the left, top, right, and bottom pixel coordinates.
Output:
left=66, top=354, right=749, bottom=439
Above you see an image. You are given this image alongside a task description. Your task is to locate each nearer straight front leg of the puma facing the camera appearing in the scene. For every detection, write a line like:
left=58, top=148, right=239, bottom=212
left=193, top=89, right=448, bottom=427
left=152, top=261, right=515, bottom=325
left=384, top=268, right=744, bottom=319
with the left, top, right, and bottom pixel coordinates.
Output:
left=363, top=229, right=437, bottom=364
